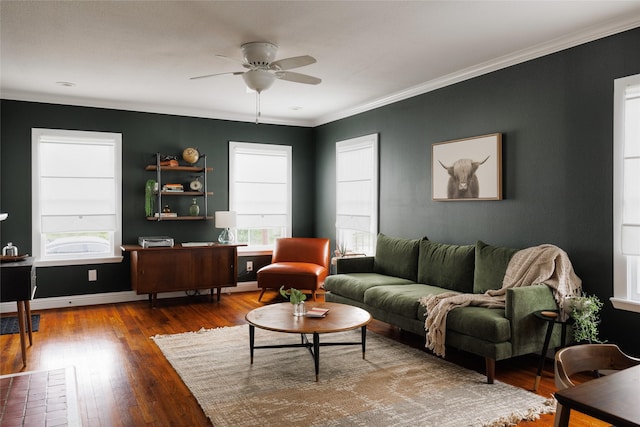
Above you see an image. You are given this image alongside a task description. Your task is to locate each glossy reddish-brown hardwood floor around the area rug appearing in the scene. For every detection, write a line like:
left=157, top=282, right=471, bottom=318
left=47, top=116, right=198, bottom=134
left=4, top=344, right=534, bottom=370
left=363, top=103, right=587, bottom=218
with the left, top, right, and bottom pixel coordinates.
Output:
left=0, top=292, right=607, bottom=427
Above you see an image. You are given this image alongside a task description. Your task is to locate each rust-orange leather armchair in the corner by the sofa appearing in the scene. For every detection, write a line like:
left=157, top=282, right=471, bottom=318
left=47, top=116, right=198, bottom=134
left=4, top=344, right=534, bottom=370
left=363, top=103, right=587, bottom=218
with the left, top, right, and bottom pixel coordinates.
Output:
left=258, top=237, right=329, bottom=301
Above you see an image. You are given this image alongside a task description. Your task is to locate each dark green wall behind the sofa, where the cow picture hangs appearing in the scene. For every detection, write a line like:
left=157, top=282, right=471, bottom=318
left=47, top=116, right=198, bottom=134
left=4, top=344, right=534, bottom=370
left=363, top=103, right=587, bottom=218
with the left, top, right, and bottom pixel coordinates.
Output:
left=316, top=25, right=640, bottom=354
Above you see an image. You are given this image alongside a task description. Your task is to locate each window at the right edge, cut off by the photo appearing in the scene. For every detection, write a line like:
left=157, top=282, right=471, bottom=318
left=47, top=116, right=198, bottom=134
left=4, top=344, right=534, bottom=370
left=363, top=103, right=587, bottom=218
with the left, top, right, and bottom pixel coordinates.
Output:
left=611, top=74, right=640, bottom=312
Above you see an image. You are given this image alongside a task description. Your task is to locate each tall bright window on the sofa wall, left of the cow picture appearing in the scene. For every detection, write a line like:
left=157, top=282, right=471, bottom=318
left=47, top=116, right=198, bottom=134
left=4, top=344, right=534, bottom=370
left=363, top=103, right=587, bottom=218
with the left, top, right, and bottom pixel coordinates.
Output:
left=336, top=134, right=378, bottom=255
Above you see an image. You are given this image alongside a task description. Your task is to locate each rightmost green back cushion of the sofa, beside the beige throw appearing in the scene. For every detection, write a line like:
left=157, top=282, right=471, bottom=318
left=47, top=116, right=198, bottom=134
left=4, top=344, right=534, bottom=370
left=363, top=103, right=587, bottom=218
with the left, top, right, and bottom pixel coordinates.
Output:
left=473, top=240, right=518, bottom=294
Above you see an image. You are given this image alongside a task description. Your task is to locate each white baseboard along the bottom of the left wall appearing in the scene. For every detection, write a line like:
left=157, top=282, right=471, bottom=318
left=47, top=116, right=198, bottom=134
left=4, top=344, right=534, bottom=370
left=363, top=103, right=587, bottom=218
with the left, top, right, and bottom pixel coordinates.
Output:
left=0, top=281, right=258, bottom=313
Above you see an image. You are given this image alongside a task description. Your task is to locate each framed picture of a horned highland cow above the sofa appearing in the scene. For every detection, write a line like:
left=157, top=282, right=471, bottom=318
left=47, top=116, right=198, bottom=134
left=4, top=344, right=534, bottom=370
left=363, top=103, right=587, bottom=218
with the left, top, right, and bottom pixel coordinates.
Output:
left=431, top=133, right=502, bottom=201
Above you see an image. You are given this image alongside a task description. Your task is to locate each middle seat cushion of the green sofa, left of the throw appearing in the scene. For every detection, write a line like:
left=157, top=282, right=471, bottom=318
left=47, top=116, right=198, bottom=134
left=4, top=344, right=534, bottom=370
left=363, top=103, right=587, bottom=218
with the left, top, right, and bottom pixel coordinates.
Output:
left=364, top=284, right=458, bottom=321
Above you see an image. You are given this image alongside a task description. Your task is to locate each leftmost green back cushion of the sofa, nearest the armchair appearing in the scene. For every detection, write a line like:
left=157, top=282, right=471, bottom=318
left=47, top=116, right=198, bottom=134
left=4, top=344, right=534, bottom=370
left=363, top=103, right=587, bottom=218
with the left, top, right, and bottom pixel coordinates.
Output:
left=373, top=233, right=420, bottom=282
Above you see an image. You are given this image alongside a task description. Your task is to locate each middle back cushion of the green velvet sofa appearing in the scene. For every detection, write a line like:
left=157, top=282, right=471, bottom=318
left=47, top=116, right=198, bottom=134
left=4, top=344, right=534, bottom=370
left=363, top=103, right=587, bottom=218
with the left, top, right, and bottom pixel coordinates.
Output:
left=418, top=240, right=475, bottom=293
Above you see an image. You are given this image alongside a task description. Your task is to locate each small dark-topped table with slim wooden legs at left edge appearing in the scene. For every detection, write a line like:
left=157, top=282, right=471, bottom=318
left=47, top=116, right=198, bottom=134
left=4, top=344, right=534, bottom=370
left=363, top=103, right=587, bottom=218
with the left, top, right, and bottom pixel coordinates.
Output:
left=0, top=257, right=36, bottom=366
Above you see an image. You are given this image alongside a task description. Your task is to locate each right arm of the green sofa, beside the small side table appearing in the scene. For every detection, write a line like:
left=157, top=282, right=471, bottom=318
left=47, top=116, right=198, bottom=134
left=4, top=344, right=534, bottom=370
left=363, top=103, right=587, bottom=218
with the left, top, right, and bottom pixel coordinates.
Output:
left=505, top=284, right=560, bottom=356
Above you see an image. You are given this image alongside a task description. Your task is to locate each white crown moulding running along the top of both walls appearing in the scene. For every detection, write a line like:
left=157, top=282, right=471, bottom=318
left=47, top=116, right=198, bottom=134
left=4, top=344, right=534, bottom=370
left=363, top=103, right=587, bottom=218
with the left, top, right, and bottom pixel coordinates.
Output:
left=1, top=16, right=640, bottom=127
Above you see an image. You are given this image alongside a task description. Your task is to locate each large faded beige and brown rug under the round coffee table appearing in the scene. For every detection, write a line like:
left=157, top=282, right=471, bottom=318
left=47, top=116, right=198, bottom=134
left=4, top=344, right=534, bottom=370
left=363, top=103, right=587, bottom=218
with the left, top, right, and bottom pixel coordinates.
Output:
left=152, top=325, right=555, bottom=427
